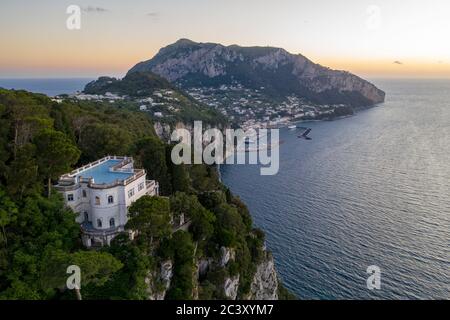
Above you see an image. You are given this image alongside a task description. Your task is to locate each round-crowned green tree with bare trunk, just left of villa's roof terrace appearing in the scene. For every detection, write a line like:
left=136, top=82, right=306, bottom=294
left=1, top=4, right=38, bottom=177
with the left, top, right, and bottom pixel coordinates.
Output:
left=35, top=129, right=80, bottom=197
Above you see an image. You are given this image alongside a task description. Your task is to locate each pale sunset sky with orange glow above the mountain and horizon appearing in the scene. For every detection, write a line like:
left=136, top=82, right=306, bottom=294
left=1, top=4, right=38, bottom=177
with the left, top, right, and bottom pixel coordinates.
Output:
left=0, top=0, right=450, bottom=78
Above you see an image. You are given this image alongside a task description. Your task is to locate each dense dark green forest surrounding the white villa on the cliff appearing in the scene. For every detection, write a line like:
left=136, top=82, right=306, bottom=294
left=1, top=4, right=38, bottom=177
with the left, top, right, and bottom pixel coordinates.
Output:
left=0, top=89, right=294, bottom=299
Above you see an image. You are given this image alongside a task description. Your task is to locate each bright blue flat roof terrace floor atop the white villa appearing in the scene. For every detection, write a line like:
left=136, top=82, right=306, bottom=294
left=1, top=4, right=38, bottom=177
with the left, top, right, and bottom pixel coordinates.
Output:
left=76, top=159, right=134, bottom=184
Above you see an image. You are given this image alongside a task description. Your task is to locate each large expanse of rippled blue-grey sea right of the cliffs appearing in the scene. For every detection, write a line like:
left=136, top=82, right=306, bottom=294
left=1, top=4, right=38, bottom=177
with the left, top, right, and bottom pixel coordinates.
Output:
left=222, top=80, right=450, bottom=299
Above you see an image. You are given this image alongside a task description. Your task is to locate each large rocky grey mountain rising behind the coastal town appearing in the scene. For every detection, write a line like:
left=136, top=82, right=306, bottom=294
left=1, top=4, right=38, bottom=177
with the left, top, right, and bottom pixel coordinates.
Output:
left=128, top=39, right=385, bottom=107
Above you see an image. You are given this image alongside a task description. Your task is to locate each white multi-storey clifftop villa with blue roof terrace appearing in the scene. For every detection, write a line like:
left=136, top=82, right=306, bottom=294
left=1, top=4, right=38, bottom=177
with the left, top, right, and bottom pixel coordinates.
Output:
left=55, top=156, right=159, bottom=247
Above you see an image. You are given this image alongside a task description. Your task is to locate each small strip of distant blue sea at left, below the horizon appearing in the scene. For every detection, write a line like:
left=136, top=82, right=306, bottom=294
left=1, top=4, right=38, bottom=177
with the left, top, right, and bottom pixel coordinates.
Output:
left=0, top=78, right=94, bottom=97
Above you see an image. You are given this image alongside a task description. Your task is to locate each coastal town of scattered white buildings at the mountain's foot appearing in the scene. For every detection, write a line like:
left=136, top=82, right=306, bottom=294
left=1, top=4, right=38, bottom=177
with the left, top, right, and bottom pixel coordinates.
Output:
left=59, top=83, right=354, bottom=130
